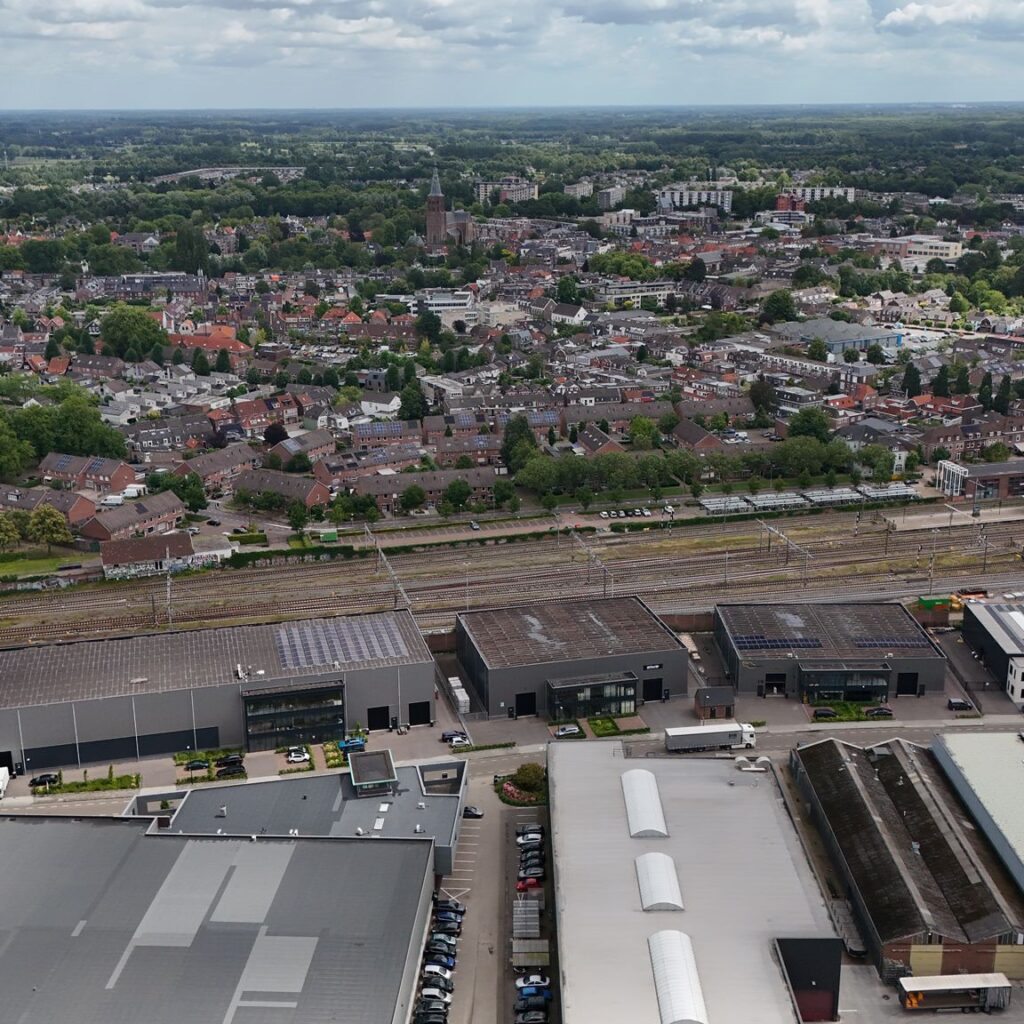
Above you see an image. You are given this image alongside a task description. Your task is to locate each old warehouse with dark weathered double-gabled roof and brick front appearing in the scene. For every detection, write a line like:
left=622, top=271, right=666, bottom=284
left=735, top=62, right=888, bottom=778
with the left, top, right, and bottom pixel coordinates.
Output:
left=791, top=735, right=1024, bottom=982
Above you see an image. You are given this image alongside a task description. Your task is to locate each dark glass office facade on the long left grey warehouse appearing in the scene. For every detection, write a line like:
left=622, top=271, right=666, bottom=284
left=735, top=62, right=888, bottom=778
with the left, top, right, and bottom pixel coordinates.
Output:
left=245, top=683, right=345, bottom=751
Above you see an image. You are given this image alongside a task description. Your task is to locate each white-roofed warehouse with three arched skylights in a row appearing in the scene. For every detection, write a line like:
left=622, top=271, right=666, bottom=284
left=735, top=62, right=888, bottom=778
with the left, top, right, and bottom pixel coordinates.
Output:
left=548, top=742, right=843, bottom=1024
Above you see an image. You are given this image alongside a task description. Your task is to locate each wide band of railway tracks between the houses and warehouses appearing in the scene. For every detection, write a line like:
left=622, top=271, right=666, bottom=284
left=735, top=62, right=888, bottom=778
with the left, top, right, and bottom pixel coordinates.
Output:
left=0, top=513, right=1024, bottom=646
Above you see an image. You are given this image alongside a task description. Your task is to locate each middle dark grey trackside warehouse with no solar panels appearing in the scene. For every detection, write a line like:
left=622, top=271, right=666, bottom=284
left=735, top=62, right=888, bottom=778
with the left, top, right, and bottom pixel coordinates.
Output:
left=456, top=597, right=687, bottom=719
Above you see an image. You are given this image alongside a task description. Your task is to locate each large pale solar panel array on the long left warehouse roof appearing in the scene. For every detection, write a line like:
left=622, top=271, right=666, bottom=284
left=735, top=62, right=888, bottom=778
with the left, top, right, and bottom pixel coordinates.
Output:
left=274, top=616, right=409, bottom=669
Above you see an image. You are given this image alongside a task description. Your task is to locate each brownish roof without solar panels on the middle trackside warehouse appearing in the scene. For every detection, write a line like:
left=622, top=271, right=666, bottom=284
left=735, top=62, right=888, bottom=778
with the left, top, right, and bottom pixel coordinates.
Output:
left=459, top=597, right=686, bottom=669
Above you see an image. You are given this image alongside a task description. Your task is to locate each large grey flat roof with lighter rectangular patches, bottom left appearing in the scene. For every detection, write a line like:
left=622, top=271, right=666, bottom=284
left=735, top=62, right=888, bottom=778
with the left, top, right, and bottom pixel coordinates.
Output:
left=0, top=816, right=432, bottom=1024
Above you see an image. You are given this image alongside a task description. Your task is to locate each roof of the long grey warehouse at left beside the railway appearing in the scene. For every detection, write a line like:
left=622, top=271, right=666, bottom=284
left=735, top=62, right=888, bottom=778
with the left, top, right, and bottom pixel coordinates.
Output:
left=0, top=610, right=431, bottom=708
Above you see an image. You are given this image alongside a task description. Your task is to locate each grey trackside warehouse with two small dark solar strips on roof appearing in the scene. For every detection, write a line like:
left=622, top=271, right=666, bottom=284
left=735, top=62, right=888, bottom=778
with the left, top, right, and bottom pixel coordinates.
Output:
left=715, top=603, right=946, bottom=701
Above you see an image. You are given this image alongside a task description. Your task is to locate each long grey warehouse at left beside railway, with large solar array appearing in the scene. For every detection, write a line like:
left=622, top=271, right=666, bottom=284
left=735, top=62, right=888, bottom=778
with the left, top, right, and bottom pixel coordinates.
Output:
left=0, top=611, right=434, bottom=772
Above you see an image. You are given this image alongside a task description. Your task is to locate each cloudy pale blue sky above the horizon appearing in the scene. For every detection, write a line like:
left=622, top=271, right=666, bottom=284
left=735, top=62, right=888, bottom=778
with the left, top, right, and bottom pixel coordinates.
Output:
left=0, top=0, right=1024, bottom=110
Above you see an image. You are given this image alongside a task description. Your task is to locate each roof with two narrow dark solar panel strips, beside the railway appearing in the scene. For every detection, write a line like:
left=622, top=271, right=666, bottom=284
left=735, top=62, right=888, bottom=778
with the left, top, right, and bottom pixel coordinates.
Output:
left=717, top=603, right=943, bottom=662
